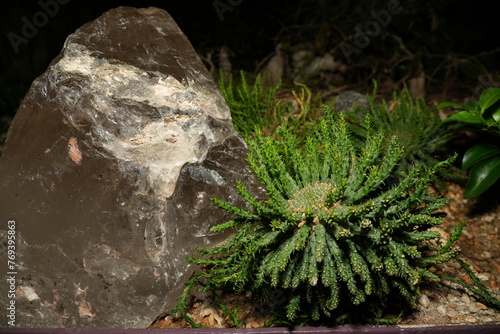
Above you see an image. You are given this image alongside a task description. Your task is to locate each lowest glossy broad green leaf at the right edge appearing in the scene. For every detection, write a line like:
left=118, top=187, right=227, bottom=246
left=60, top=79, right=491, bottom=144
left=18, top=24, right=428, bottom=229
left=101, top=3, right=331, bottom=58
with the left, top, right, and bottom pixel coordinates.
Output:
left=464, top=156, right=500, bottom=198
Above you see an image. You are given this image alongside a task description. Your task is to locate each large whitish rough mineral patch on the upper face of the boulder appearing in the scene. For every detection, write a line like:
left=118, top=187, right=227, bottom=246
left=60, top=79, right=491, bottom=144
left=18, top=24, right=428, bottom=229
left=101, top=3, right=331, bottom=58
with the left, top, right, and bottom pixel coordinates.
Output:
left=55, top=44, right=230, bottom=199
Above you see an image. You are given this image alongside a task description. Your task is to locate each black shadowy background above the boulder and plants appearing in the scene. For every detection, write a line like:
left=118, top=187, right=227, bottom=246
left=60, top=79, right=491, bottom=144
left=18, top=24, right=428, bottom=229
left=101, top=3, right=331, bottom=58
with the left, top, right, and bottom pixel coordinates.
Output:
left=0, top=0, right=500, bottom=122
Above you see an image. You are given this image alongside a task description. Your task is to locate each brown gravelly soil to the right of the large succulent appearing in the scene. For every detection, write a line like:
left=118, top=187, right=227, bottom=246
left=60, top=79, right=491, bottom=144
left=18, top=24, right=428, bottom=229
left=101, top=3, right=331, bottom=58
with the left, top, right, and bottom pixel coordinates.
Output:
left=398, top=184, right=500, bottom=326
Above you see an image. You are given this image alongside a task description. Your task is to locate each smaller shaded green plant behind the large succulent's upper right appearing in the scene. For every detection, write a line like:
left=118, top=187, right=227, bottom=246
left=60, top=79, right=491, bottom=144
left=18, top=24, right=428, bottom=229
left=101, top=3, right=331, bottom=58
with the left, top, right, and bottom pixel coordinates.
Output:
left=346, top=88, right=460, bottom=180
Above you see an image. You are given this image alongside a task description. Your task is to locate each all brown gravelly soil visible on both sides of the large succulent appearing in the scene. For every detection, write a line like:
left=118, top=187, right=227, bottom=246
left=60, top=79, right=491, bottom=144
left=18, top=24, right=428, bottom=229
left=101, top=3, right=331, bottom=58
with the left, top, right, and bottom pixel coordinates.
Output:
left=151, top=183, right=500, bottom=328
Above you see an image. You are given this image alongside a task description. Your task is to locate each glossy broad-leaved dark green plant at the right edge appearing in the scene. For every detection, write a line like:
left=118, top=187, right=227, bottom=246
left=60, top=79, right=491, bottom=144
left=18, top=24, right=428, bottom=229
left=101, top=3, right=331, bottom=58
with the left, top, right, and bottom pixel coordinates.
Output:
left=437, top=87, right=500, bottom=198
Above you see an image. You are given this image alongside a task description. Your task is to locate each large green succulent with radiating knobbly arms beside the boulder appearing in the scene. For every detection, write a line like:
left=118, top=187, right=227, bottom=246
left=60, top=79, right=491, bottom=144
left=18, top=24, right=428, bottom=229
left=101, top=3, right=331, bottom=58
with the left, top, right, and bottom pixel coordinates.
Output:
left=176, top=110, right=456, bottom=323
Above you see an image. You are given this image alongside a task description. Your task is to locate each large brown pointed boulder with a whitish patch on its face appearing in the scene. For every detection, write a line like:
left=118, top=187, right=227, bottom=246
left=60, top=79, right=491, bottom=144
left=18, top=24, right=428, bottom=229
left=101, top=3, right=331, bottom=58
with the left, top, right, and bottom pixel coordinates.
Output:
left=0, top=7, right=258, bottom=328
